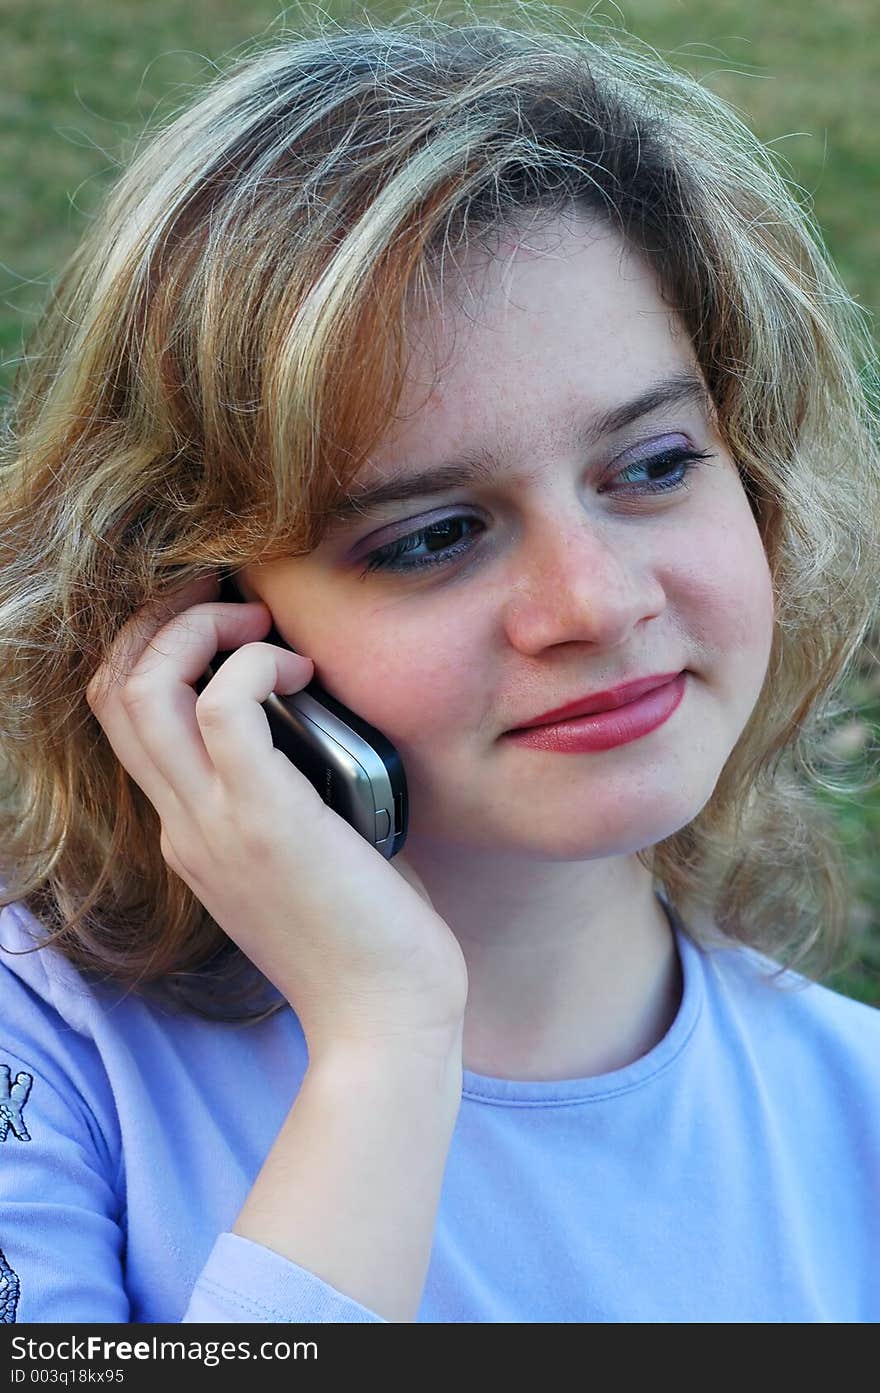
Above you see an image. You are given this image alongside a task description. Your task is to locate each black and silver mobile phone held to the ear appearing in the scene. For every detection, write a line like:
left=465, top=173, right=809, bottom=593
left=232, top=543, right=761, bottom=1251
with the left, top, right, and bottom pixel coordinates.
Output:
left=196, top=574, right=408, bottom=861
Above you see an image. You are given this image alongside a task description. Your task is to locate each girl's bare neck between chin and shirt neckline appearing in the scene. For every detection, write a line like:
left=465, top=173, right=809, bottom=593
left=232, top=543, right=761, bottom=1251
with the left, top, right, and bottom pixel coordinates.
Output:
left=395, top=843, right=682, bottom=1080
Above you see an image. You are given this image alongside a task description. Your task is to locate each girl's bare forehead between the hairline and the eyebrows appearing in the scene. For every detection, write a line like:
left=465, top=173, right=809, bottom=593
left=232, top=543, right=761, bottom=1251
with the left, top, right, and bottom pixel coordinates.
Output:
left=370, top=215, right=699, bottom=465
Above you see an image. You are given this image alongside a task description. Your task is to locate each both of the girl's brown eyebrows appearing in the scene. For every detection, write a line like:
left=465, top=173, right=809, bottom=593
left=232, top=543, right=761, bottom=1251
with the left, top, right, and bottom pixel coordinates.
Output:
left=324, top=371, right=713, bottom=522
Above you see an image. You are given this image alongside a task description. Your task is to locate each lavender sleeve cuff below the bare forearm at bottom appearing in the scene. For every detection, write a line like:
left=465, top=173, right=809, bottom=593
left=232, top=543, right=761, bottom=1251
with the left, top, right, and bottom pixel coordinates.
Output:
left=184, top=1233, right=387, bottom=1325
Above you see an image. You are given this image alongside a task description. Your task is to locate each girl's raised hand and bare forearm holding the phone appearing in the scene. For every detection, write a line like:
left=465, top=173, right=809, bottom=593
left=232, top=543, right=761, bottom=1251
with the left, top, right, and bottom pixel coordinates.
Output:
left=79, top=577, right=468, bottom=1321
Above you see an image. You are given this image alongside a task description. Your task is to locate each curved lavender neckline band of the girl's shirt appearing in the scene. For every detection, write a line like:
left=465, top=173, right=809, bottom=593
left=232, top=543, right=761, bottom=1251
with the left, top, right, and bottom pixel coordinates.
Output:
left=461, top=890, right=705, bottom=1107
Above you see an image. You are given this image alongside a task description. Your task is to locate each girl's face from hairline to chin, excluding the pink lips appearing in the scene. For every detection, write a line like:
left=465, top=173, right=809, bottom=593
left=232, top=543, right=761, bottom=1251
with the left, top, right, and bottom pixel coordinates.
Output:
left=241, top=221, right=774, bottom=861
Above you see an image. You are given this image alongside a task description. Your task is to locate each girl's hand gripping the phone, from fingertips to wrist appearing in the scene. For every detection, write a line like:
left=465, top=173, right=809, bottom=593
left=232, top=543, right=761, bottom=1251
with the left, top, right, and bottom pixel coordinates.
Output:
left=86, top=578, right=468, bottom=1053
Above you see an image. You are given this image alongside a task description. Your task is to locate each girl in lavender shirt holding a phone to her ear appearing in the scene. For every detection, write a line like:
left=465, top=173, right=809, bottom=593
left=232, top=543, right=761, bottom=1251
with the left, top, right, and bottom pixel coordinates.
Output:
left=0, top=5, right=880, bottom=1322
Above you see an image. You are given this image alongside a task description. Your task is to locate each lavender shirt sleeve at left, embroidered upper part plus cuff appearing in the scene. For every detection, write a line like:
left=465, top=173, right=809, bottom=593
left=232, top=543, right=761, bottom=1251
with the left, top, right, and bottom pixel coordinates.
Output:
left=0, top=907, right=384, bottom=1325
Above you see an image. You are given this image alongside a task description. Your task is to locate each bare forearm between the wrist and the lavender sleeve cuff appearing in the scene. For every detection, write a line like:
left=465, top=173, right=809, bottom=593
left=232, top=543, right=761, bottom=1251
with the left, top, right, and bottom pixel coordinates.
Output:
left=226, top=1032, right=461, bottom=1322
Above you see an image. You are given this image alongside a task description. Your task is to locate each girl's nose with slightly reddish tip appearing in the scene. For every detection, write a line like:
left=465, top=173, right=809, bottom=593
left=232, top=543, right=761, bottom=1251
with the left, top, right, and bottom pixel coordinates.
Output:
left=505, top=508, right=666, bottom=655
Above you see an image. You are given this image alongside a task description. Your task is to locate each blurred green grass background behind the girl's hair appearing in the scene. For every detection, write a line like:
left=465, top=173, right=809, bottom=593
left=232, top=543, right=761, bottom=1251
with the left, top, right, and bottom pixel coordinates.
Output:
left=0, top=0, right=880, bottom=1006
